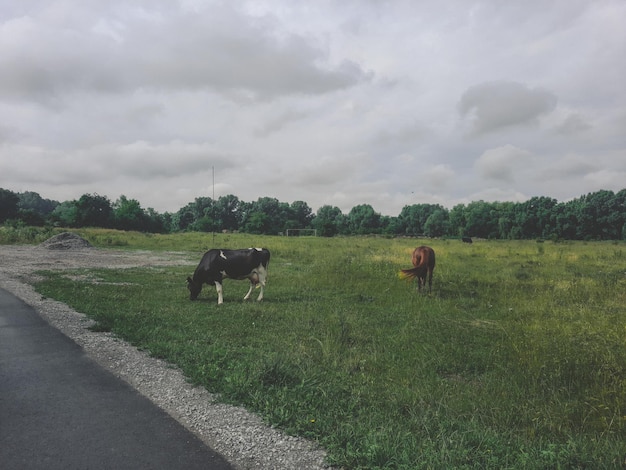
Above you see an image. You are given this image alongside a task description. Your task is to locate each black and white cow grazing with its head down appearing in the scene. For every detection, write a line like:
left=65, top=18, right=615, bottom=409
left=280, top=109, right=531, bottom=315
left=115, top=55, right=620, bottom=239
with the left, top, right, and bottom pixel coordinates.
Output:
left=187, top=248, right=270, bottom=305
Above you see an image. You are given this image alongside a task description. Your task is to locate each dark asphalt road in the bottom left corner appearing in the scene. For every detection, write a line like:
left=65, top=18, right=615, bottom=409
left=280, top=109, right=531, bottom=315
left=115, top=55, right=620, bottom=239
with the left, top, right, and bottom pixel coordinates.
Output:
left=0, top=289, right=232, bottom=470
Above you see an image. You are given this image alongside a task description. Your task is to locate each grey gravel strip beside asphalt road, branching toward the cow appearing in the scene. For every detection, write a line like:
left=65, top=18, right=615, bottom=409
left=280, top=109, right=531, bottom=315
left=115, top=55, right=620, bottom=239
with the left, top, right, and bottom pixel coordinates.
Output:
left=0, top=245, right=328, bottom=470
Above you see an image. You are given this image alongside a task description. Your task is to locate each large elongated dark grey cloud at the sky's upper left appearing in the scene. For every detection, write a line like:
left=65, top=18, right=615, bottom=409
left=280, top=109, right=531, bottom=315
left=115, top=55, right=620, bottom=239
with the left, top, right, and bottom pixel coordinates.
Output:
left=0, top=6, right=368, bottom=103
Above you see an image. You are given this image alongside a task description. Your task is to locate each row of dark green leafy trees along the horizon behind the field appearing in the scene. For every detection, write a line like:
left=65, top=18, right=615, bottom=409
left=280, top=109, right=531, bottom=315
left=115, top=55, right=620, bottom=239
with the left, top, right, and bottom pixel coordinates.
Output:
left=0, top=188, right=626, bottom=240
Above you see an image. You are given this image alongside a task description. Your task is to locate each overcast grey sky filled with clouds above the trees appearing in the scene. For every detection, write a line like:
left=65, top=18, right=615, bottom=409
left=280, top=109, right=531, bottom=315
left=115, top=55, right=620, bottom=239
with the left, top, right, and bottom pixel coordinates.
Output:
left=0, top=0, right=626, bottom=215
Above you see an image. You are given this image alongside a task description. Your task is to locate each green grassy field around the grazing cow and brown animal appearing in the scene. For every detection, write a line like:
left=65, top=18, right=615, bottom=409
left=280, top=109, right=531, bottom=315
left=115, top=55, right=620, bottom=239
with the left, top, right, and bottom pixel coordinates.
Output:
left=17, top=230, right=626, bottom=469
